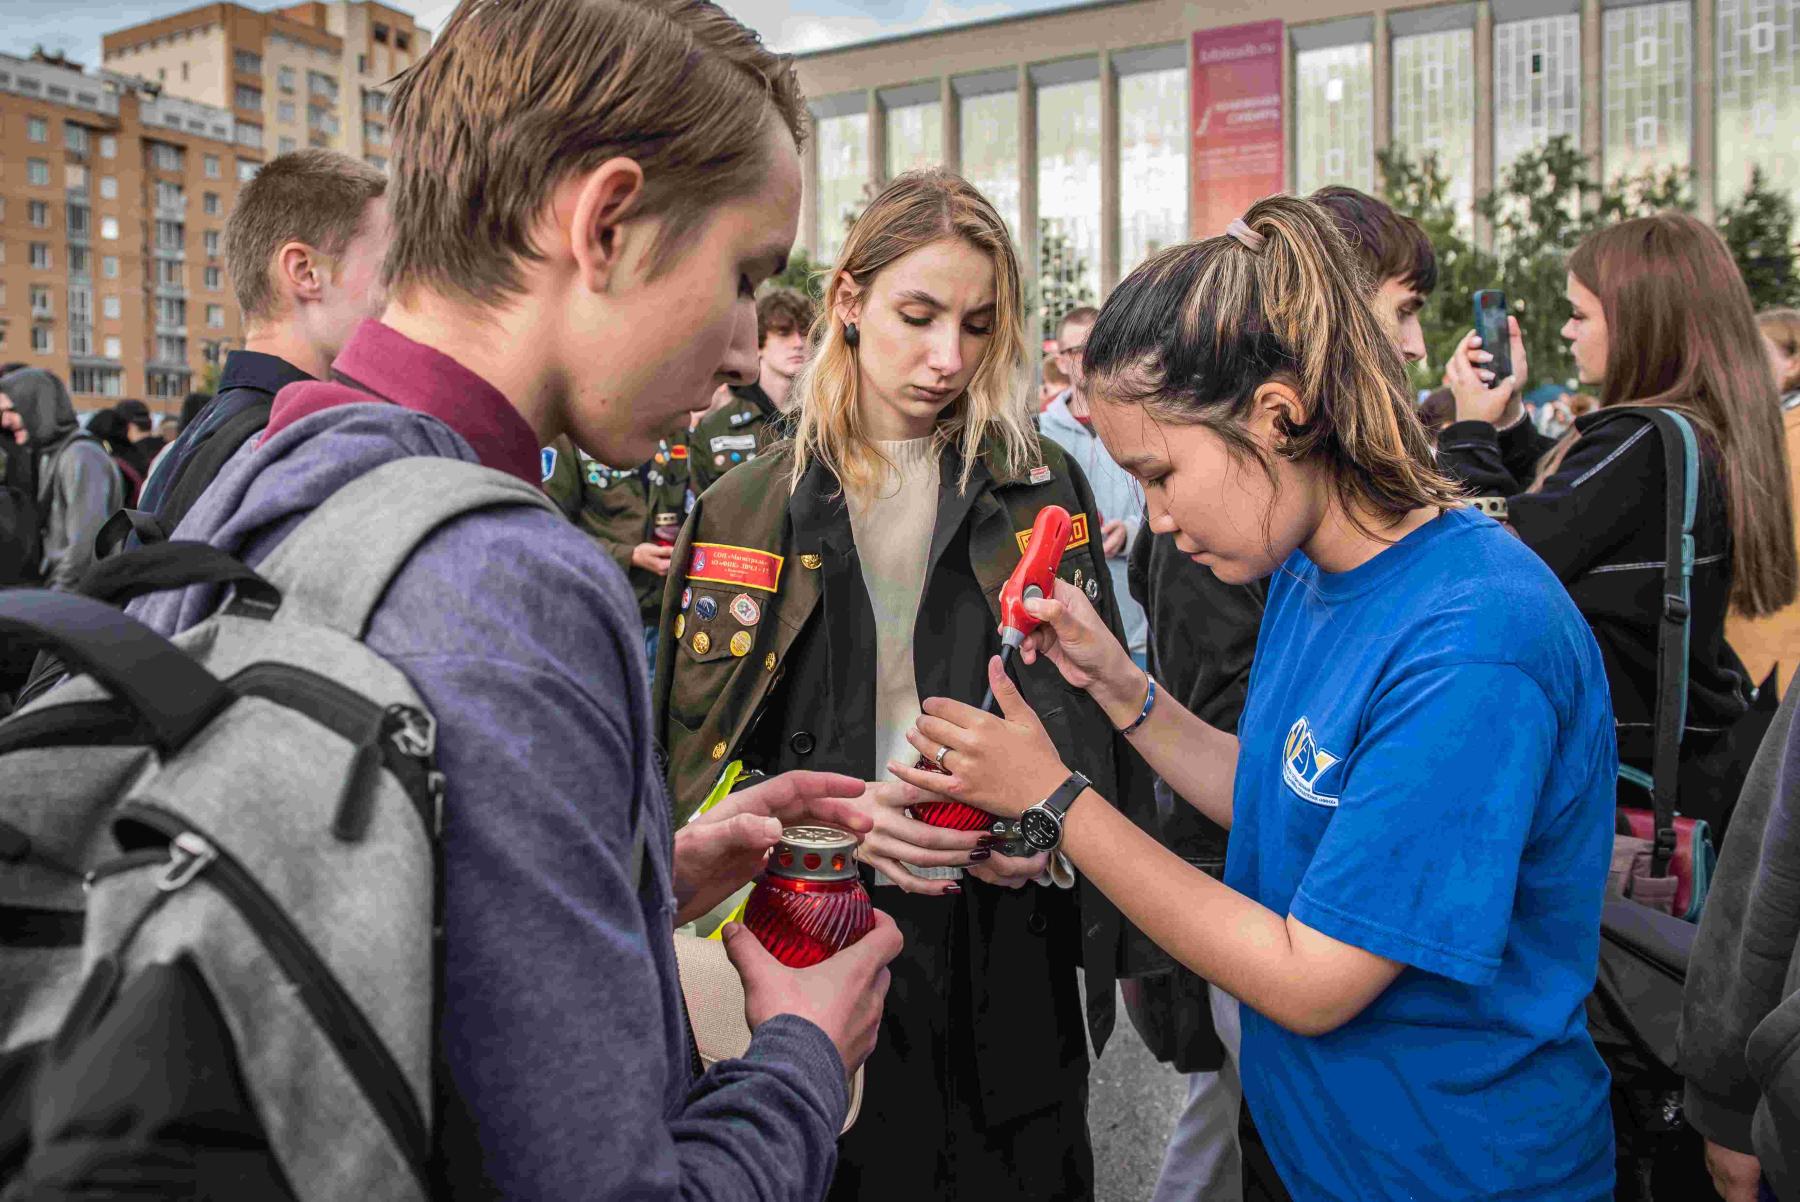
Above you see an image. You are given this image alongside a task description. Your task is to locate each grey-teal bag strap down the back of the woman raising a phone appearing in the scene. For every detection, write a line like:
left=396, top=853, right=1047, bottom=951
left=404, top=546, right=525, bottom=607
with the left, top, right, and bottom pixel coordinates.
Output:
left=1638, top=408, right=1699, bottom=876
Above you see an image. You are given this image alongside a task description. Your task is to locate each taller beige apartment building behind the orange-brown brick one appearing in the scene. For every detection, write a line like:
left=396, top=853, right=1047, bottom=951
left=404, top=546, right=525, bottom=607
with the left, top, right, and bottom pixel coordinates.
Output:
left=103, top=0, right=430, bottom=169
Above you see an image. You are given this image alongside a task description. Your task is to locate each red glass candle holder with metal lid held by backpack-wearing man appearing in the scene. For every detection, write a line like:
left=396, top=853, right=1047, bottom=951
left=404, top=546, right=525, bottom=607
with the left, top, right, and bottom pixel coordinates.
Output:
left=743, top=826, right=875, bottom=968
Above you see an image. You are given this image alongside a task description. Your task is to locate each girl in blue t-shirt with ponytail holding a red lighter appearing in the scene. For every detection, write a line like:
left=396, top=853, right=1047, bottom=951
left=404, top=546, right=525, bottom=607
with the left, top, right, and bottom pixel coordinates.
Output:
left=889, top=196, right=1616, bottom=1200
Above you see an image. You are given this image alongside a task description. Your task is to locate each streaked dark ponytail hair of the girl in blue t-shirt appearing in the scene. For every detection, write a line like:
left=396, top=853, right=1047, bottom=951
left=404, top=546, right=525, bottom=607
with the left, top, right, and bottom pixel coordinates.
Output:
left=1084, top=196, right=1460, bottom=524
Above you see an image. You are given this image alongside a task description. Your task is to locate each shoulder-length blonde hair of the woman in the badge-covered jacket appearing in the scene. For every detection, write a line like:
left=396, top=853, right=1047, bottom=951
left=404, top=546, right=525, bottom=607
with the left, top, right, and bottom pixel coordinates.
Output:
left=788, top=169, right=1037, bottom=495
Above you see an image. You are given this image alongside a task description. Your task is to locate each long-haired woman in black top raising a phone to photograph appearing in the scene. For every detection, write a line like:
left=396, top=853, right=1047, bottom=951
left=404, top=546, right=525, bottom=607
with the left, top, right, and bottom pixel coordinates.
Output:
left=1438, top=212, right=1800, bottom=839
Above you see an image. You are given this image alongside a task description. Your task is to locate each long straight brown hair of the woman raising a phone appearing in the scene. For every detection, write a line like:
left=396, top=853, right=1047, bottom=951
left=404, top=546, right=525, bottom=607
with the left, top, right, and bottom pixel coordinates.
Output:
left=1562, top=212, right=1800, bottom=617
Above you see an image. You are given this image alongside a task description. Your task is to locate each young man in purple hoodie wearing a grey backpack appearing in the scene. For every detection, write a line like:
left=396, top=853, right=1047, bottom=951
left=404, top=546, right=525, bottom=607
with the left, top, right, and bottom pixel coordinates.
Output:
left=0, top=0, right=898, bottom=1202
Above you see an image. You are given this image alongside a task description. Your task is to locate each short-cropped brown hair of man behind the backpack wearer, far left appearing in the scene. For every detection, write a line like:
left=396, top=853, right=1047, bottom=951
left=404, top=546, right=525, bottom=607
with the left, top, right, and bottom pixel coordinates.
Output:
left=225, top=148, right=387, bottom=326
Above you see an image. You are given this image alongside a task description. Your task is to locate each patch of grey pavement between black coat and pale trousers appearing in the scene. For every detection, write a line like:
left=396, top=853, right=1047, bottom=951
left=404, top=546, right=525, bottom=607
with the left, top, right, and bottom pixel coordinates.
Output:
left=1087, top=1000, right=1188, bottom=1202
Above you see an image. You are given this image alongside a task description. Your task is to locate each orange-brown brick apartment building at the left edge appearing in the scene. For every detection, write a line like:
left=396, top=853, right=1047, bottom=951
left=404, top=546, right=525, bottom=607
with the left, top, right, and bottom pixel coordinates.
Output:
left=0, top=54, right=263, bottom=412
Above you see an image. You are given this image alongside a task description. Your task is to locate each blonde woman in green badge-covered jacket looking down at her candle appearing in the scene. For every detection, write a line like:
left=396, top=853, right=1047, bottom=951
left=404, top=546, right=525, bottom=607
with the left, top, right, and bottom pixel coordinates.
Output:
left=653, top=171, right=1148, bottom=1202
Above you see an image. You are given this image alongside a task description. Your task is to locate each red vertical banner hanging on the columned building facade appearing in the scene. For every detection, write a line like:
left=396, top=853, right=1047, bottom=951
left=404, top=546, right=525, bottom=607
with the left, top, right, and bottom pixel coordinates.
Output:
left=1188, top=22, right=1287, bottom=238
